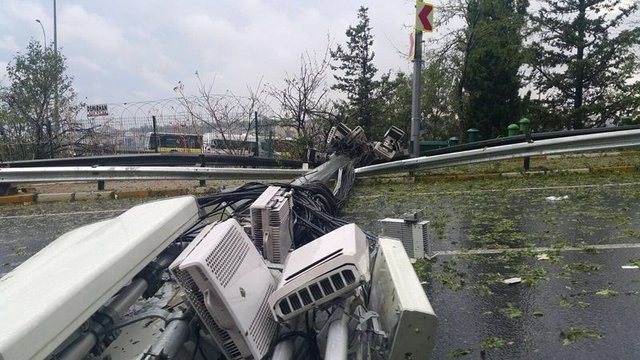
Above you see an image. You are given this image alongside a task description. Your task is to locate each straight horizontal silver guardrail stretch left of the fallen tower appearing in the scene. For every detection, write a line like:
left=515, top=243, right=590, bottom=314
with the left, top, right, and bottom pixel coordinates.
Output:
left=0, top=166, right=308, bottom=183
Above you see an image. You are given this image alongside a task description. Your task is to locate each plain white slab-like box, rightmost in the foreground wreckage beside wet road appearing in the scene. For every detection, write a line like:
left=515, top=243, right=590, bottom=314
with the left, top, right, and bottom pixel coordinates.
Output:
left=369, top=237, right=438, bottom=360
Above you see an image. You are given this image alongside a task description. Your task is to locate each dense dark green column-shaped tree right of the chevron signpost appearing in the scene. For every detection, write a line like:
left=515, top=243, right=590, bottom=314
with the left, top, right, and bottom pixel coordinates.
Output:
left=461, top=0, right=529, bottom=137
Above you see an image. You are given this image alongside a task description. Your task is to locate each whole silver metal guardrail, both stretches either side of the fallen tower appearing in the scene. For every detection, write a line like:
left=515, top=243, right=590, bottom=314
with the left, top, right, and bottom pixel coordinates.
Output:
left=0, top=129, right=640, bottom=184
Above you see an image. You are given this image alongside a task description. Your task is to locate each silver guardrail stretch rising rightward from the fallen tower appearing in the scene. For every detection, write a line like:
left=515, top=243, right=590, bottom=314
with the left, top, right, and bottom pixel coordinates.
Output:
left=356, top=129, right=640, bottom=176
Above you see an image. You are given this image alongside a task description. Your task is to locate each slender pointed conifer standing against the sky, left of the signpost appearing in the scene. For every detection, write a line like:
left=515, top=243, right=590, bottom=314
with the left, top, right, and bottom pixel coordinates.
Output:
left=331, top=6, right=378, bottom=131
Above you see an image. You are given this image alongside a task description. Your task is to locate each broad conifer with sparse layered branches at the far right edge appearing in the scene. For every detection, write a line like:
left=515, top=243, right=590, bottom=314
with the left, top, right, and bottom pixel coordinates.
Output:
left=531, top=0, right=640, bottom=129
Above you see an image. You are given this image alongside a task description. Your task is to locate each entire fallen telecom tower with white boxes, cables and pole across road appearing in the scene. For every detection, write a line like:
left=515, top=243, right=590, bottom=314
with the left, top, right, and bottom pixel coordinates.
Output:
left=0, top=124, right=437, bottom=360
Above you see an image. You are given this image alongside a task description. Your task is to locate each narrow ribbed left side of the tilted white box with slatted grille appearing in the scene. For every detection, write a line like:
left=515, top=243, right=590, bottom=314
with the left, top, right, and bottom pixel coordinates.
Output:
left=173, top=268, right=242, bottom=360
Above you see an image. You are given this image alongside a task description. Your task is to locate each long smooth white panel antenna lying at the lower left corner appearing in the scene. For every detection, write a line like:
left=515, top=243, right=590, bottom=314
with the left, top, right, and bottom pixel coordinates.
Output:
left=0, top=196, right=198, bottom=360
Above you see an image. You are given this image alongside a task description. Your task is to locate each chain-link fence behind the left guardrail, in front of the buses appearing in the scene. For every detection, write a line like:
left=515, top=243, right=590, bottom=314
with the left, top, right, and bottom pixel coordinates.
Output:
left=0, top=99, right=293, bottom=161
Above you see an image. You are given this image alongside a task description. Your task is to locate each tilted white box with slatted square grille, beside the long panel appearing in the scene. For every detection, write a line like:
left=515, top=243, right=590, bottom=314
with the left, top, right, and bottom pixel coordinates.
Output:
left=169, top=219, right=277, bottom=359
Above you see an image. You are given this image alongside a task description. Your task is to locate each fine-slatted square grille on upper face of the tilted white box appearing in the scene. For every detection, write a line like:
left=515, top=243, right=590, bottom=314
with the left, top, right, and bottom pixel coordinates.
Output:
left=206, top=227, right=249, bottom=287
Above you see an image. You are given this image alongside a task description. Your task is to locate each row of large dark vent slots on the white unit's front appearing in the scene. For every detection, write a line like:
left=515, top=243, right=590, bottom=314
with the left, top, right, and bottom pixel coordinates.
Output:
left=276, top=269, right=357, bottom=316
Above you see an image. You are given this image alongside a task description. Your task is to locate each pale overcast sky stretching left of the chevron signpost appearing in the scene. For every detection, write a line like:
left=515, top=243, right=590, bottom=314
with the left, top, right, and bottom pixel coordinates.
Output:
left=0, top=0, right=415, bottom=104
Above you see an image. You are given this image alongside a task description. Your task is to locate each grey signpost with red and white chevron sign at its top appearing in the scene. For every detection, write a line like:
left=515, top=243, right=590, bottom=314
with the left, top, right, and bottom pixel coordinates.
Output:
left=409, top=1, right=434, bottom=157
